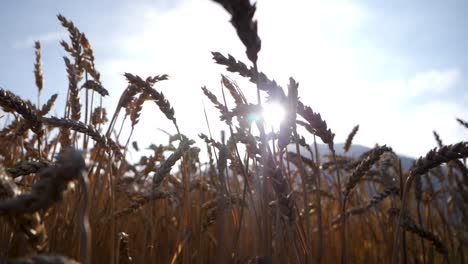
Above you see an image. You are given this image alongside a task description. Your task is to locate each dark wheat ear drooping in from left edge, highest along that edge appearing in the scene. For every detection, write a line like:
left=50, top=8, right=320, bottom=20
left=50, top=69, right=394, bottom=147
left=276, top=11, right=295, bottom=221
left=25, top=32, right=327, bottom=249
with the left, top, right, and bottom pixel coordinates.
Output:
left=0, top=88, right=42, bottom=135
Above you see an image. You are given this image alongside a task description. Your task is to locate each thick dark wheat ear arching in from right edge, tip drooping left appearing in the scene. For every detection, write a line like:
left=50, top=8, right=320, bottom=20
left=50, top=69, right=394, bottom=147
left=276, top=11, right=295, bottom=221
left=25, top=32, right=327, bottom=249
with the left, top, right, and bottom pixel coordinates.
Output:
left=410, top=142, right=468, bottom=175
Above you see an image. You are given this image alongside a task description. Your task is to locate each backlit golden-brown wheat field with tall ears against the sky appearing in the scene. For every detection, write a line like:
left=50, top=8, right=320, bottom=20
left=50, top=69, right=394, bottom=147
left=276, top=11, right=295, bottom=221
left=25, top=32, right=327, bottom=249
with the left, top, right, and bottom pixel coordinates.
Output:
left=0, top=0, right=468, bottom=263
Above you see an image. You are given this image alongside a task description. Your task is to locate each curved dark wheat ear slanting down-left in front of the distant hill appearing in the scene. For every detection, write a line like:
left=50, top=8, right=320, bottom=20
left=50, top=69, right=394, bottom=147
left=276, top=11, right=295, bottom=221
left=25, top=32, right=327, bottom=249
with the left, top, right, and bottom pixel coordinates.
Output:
left=343, top=145, right=392, bottom=197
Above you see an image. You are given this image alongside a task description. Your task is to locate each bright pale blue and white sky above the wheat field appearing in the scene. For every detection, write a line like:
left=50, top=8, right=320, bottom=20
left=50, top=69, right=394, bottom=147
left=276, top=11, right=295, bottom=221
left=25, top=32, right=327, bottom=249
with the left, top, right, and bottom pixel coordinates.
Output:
left=0, top=0, right=468, bottom=157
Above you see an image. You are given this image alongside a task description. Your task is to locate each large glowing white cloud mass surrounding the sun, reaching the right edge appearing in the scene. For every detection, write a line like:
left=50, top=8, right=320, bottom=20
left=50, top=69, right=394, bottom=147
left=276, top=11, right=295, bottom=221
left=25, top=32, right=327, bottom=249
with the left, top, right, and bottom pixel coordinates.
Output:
left=99, top=0, right=468, bottom=156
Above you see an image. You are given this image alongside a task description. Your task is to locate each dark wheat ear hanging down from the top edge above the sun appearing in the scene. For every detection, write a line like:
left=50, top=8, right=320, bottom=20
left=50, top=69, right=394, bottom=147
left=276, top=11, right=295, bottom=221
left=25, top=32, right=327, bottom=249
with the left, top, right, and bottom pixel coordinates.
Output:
left=214, top=0, right=262, bottom=65
